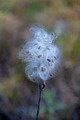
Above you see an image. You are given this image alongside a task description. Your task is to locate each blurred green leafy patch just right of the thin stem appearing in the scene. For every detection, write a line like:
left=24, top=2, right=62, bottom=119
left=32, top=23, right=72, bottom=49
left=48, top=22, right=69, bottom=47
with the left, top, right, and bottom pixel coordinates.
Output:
left=40, top=89, right=64, bottom=120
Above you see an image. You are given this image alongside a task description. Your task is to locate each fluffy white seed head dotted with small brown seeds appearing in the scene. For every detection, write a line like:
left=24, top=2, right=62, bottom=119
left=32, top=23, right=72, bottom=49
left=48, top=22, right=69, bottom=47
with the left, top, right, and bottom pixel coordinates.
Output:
left=19, top=27, right=62, bottom=82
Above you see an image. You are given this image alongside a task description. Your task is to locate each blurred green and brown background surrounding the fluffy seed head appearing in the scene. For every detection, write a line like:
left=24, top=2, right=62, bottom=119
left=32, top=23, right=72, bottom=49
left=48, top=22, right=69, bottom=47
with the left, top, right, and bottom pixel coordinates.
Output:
left=0, top=0, right=80, bottom=120
